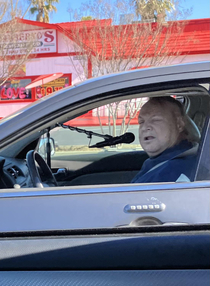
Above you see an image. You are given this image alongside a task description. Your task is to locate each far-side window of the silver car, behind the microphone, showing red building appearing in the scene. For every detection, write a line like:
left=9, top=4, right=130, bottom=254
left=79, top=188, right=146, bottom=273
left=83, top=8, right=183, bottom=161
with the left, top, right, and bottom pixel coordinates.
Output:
left=45, top=97, right=148, bottom=170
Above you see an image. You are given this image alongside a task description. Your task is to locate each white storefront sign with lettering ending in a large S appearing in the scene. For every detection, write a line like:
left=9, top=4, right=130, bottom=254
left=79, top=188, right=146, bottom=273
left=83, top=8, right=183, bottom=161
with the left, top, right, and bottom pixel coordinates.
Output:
left=0, top=29, right=57, bottom=55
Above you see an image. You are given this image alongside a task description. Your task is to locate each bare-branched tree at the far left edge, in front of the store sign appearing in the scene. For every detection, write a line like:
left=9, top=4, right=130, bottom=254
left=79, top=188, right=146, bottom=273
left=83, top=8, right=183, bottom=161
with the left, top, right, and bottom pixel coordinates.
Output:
left=0, top=0, right=33, bottom=86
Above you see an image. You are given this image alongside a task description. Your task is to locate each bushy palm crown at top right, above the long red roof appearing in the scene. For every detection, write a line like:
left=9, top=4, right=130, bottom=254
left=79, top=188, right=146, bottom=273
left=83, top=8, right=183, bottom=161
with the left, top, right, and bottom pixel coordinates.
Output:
left=133, top=0, right=175, bottom=21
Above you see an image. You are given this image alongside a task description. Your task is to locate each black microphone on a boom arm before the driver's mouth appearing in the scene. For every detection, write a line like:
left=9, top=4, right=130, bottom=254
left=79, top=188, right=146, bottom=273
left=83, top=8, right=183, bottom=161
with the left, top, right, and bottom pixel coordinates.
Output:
left=89, top=132, right=135, bottom=148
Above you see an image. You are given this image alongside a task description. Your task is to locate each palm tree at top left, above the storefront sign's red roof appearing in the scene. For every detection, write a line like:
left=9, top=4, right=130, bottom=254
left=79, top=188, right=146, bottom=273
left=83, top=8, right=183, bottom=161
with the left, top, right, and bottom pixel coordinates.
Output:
left=30, top=0, right=59, bottom=23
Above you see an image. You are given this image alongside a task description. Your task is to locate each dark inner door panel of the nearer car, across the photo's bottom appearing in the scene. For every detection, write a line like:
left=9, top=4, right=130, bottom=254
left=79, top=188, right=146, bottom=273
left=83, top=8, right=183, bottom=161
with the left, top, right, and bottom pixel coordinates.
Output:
left=0, top=225, right=210, bottom=286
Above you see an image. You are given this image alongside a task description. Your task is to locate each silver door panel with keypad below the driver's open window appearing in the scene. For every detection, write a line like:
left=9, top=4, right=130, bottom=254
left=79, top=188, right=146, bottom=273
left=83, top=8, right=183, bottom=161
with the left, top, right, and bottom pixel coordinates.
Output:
left=0, top=182, right=210, bottom=232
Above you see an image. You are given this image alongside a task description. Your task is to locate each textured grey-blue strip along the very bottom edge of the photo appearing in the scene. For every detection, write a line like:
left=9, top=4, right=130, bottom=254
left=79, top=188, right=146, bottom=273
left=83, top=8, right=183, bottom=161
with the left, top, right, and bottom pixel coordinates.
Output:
left=0, top=270, right=210, bottom=286
